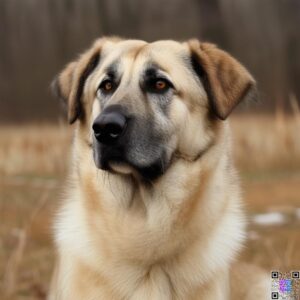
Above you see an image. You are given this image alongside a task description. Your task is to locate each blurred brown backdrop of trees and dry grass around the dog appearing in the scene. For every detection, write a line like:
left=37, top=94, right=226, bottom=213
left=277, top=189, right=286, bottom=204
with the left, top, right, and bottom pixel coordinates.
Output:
left=0, top=0, right=300, bottom=300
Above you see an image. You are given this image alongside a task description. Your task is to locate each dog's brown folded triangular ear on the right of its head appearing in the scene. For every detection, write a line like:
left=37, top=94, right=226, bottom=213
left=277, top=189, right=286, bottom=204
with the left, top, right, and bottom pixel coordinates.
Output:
left=188, top=40, right=255, bottom=120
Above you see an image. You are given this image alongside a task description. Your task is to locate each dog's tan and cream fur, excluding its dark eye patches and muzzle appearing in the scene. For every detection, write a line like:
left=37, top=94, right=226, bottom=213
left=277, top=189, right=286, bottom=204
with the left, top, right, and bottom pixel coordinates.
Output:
left=49, top=39, right=265, bottom=300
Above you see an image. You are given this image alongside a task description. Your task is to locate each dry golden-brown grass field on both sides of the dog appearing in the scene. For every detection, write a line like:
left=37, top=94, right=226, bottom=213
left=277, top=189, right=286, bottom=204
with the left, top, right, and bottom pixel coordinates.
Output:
left=0, top=115, right=300, bottom=300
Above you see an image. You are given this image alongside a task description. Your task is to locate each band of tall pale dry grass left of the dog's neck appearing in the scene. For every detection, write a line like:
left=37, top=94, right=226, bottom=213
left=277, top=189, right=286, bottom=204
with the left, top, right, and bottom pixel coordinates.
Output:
left=0, top=125, right=71, bottom=176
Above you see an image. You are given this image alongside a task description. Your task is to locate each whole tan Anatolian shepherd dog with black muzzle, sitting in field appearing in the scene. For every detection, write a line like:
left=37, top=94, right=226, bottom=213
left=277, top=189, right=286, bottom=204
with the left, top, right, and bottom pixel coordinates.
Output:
left=49, top=38, right=269, bottom=300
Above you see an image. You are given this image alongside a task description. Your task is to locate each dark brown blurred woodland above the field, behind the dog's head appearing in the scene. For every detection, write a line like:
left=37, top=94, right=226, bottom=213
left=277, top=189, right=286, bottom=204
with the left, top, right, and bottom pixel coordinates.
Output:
left=0, top=0, right=300, bottom=123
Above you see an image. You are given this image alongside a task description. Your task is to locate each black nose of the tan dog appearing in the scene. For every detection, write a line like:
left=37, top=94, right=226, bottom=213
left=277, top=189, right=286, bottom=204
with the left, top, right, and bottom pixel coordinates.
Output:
left=93, top=111, right=126, bottom=145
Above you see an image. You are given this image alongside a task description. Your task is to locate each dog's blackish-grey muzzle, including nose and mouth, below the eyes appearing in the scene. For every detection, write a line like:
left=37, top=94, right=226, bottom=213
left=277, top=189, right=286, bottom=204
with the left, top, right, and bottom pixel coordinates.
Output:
left=92, top=105, right=167, bottom=180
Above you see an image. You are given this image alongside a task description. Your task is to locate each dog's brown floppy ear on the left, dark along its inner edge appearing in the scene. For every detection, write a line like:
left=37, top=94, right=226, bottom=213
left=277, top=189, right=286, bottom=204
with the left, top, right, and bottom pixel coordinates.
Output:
left=51, top=39, right=103, bottom=124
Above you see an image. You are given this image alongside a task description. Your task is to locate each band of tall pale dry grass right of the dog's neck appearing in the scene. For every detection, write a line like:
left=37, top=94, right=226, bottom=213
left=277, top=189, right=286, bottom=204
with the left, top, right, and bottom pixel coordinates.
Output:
left=231, top=115, right=300, bottom=171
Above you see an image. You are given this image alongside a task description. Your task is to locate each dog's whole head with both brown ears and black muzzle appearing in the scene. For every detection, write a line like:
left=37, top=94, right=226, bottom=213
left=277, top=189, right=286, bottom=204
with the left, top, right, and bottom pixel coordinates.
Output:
left=53, top=38, right=255, bottom=180
